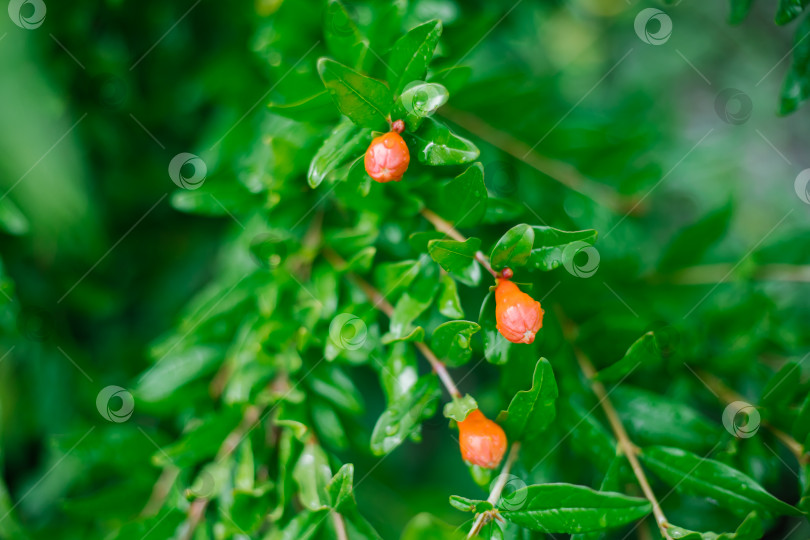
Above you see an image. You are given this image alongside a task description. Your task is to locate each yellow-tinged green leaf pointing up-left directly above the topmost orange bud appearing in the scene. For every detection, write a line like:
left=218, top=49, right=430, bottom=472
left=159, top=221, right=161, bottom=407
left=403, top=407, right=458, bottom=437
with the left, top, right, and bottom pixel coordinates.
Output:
left=318, top=58, right=393, bottom=130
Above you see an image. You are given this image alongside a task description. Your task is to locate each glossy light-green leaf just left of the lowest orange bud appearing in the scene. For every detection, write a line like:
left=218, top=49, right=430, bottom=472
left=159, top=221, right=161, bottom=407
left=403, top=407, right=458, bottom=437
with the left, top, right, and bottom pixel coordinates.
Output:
left=371, top=374, right=441, bottom=456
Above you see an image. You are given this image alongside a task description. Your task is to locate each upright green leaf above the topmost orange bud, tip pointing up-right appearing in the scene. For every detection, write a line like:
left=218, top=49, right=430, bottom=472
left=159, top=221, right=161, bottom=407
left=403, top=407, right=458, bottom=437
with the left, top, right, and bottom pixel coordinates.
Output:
left=388, top=19, right=442, bottom=94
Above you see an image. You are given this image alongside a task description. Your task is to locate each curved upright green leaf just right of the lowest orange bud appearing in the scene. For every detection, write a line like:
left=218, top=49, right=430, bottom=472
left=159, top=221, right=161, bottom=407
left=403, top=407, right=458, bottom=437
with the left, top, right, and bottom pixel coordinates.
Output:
left=498, top=358, right=558, bottom=441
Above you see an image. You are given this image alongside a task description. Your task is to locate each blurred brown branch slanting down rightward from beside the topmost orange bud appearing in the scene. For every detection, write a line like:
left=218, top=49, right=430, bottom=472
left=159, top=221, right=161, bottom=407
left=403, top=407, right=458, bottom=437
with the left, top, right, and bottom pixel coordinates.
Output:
left=440, top=107, right=642, bottom=214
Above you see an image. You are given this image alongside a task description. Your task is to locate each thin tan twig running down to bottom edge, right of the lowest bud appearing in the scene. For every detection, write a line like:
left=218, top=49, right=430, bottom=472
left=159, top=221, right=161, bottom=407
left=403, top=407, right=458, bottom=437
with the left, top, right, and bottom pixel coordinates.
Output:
left=558, top=310, right=672, bottom=540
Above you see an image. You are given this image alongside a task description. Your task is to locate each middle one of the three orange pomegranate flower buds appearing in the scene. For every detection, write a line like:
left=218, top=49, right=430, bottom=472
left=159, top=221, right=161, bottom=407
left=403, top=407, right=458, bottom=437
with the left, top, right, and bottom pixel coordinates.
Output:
left=495, top=268, right=544, bottom=343
